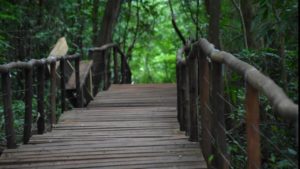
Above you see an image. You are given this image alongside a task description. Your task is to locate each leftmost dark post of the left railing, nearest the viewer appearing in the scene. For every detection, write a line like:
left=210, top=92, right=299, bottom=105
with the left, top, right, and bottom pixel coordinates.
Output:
left=2, top=72, right=17, bottom=149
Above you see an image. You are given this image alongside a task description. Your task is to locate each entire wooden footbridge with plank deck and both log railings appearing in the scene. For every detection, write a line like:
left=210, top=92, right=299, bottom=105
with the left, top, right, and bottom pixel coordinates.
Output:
left=0, top=39, right=298, bottom=169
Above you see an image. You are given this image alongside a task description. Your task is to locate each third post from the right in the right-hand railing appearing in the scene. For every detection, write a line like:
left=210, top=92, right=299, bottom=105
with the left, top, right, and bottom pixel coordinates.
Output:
left=198, top=51, right=212, bottom=161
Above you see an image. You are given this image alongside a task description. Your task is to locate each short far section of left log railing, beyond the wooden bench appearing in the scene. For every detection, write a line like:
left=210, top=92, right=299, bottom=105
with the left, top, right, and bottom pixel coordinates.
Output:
left=89, top=43, right=131, bottom=95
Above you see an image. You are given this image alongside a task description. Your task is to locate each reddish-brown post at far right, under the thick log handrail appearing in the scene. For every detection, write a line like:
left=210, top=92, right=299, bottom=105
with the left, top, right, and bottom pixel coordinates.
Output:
left=245, top=83, right=261, bottom=169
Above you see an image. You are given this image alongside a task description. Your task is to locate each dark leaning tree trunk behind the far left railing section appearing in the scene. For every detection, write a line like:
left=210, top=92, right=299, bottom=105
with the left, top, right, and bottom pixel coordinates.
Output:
left=92, top=0, right=122, bottom=94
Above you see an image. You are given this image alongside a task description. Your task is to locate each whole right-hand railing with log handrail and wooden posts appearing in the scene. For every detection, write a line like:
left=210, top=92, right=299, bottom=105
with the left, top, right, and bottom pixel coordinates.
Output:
left=176, top=39, right=298, bottom=168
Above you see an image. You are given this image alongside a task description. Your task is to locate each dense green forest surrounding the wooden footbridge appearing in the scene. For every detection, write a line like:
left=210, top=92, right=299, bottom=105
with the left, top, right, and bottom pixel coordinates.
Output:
left=0, top=0, right=298, bottom=169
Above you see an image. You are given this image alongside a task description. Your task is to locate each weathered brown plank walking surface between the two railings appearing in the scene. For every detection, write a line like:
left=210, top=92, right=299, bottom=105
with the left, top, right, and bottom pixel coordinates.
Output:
left=0, top=84, right=206, bottom=169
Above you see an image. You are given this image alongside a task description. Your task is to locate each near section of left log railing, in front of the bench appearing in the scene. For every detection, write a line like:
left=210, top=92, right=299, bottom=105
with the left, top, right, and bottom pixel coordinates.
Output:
left=0, top=54, right=82, bottom=148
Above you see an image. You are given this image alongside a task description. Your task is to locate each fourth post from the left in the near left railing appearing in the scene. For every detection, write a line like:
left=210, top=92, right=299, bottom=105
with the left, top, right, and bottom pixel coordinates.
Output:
left=50, top=61, right=56, bottom=128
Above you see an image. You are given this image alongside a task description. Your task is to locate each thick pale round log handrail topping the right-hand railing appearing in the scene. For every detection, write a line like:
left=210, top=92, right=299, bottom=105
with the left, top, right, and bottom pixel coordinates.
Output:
left=199, top=39, right=299, bottom=120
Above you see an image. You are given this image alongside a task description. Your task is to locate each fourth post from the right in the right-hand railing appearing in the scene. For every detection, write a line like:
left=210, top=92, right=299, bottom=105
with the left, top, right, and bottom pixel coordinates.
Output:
left=187, top=49, right=198, bottom=141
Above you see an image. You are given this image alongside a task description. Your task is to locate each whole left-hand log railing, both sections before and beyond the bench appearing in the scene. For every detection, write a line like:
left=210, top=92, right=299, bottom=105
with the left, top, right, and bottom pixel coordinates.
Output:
left=0, top=43, right=131, bottom=149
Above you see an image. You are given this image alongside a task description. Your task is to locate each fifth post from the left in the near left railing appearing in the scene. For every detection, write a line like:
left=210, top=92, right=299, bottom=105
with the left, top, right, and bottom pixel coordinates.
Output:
left=60, top=57, right=66, bottom=113
